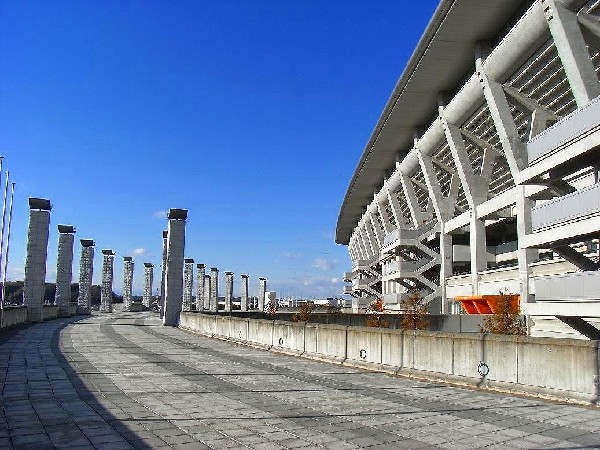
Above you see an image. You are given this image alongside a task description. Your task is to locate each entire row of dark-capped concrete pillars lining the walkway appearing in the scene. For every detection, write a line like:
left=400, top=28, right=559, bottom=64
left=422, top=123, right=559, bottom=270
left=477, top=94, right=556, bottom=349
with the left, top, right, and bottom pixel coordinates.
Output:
left=23, top=202, right=267, bottom=326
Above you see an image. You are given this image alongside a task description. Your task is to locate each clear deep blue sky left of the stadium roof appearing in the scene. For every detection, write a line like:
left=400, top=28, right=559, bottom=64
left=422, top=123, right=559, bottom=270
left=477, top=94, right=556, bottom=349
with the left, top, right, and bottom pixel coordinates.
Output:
left=0, top=0, right=438, bottom=296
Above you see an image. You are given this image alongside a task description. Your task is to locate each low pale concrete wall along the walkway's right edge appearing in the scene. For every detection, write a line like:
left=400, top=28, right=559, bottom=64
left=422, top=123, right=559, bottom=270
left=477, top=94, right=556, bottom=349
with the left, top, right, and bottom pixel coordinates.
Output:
left=179, top=312, right=600, bottom=404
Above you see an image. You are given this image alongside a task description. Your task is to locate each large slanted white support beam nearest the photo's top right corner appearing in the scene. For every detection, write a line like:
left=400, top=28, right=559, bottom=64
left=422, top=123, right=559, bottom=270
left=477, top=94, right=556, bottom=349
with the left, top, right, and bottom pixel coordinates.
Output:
left=542, top=0, right=600, bottom=107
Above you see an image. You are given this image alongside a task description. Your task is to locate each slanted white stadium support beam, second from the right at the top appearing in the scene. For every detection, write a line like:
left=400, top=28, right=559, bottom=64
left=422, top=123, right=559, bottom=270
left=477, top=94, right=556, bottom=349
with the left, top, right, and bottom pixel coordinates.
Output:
left=475, top=58, right=527, bottom=180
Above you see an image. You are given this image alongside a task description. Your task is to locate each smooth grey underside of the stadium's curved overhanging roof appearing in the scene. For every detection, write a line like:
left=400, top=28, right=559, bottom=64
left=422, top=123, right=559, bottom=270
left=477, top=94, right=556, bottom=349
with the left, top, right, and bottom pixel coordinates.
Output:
left=335, top=0, right=531, bottom=244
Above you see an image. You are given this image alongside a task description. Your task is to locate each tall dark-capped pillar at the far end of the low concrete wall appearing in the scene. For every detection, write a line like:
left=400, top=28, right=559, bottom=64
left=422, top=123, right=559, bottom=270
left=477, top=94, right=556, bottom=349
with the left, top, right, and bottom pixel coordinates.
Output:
left=163, top=208, right=187, bottom=327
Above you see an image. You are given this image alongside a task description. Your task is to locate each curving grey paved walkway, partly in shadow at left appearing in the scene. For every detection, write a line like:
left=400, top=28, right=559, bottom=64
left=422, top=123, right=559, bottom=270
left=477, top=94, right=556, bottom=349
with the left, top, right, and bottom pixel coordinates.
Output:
left=0, top=313, right=600, bottom=450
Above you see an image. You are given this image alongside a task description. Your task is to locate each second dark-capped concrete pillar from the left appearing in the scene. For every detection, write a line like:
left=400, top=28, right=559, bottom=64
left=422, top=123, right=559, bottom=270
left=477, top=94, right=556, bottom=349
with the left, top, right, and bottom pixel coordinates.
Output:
left=54, top=225, right=75, bottom=317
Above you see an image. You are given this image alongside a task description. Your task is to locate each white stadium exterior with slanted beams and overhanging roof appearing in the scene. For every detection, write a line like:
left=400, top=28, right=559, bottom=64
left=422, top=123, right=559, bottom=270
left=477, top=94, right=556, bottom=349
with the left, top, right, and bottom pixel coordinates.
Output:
left=336, top=0, right=600, bottom=337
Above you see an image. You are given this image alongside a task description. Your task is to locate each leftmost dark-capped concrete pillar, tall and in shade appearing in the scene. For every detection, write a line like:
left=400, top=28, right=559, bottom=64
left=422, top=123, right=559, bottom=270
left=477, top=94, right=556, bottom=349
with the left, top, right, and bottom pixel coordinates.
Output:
left=23, top=198, right=52, bottom=322
